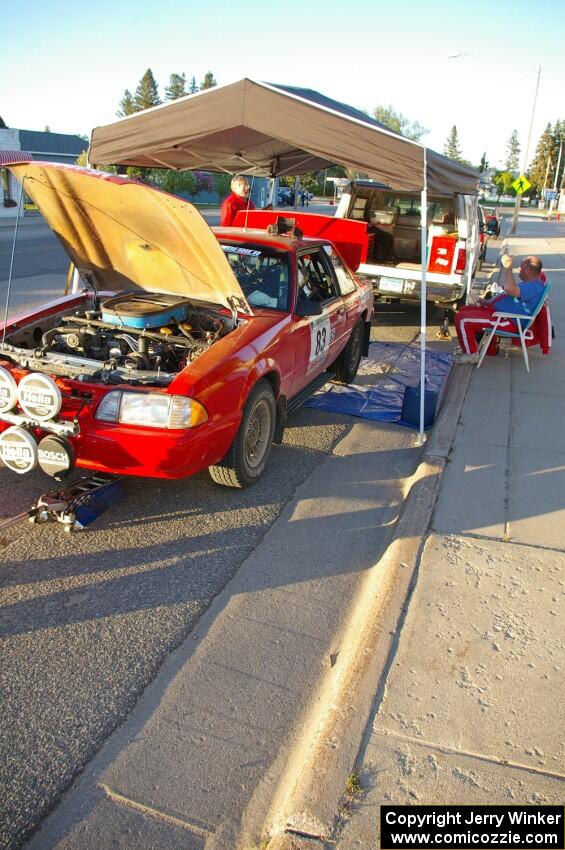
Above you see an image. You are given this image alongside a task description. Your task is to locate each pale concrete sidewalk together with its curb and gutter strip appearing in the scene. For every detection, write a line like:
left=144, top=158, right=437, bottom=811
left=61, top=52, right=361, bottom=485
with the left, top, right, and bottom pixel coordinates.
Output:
left=18, top=221, right=565, bottom=850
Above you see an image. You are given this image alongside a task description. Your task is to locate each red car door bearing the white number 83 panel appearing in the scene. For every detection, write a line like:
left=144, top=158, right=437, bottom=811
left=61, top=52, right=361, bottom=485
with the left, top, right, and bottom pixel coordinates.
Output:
left=292, top=246, right=346, bottom=395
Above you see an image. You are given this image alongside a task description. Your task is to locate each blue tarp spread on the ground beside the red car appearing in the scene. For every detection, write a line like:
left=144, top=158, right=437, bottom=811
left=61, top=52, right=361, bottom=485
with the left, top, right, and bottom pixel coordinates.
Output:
left=306, top=342, right=453, bottom=427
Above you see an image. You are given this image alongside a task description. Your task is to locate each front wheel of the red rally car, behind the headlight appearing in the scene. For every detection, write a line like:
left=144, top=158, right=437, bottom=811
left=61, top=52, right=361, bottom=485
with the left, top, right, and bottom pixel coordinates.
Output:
left=209, top=380, right=275, bottom=487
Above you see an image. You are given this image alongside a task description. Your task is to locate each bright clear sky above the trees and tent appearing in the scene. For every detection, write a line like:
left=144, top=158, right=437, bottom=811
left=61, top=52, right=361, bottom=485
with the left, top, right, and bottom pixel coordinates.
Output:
left=5, top=0, right=565, bottom=171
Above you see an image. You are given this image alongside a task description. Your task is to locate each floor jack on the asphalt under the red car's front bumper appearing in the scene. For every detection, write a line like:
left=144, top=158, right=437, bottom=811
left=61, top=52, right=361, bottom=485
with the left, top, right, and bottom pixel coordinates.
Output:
left=0, top=474, right=123, bottom=533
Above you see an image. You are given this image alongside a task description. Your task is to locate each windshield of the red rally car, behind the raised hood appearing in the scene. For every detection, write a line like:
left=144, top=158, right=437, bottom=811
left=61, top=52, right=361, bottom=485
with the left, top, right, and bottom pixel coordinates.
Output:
left=220, top=242, right=290, bottom=311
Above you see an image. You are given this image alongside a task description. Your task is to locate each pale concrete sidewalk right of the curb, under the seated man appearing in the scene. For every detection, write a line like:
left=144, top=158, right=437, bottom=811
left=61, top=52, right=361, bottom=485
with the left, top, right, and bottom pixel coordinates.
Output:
left=330, top=229, right=565, bottom=850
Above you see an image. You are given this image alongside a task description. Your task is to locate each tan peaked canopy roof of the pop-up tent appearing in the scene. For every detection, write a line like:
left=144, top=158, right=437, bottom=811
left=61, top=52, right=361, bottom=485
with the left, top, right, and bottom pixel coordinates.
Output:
left=89, top=79, right=478, bottom=193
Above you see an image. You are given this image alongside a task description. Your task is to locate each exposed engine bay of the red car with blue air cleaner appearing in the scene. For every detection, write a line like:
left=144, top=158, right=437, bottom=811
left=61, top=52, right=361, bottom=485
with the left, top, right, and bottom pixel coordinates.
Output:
left=0, top=291, right=236, bottom=386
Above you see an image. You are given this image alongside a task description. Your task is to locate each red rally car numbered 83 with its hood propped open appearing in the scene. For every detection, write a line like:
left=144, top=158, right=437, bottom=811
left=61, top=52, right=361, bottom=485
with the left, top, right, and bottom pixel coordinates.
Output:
left=0, top=162, right=373, bottom=487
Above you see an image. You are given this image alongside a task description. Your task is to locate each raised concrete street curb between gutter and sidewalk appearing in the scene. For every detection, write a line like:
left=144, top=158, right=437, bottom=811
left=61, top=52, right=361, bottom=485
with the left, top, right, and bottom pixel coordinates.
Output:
left=262, top=365, right=473, bottom=850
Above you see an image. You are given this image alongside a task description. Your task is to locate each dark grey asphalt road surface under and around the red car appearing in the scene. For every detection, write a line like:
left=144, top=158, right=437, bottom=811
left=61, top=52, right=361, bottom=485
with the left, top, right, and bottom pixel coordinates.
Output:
left=0, top=217, right=454, bottom=848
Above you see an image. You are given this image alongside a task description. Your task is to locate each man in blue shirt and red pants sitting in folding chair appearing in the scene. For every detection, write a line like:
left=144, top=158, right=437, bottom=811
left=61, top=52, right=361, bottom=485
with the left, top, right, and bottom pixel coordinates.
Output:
left=455, top=254, right=545, bottom=371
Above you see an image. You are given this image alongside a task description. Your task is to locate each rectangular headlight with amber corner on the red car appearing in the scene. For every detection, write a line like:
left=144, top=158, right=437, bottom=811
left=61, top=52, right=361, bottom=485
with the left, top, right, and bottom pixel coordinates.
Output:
left=95, top=390, right=208, bottom=429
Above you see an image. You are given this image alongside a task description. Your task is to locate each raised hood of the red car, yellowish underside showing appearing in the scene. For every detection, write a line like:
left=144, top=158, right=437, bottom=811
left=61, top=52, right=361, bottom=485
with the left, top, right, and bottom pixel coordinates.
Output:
left=9, top=162, right=251, bottom=314
